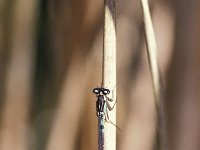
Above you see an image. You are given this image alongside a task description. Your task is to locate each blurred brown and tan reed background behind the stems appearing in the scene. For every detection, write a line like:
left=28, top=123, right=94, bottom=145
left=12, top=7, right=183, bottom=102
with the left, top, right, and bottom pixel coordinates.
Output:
left=0, top=0, right=200, bottom=150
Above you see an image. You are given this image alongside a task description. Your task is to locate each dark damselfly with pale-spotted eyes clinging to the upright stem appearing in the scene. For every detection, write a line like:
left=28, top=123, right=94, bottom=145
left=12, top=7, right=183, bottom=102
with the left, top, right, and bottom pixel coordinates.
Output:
left=93, top=87, right=116, bottom=150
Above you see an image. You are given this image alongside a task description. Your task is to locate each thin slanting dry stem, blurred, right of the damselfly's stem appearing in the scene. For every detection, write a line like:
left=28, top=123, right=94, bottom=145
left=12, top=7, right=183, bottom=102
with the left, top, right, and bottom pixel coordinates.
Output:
left=141, top=0, right=166, bottom=150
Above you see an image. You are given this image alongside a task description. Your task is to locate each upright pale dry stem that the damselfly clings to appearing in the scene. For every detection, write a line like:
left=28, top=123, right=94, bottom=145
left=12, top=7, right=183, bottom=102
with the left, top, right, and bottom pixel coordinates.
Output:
left=102, top=0, right=116, bottom=150
